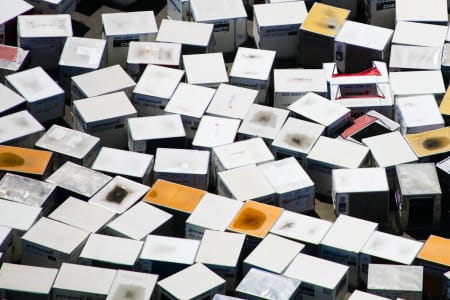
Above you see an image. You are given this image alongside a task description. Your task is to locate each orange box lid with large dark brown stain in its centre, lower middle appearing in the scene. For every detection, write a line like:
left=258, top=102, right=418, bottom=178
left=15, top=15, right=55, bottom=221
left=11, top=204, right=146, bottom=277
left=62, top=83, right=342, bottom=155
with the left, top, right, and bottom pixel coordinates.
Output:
left=228, top=200, right=283, bottom=238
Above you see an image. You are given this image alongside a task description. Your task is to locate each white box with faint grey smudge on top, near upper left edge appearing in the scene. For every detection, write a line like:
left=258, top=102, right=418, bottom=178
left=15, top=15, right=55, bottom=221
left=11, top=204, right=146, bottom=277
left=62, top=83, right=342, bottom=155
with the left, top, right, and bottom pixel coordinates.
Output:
left=5, top=67, right=64, bottom=122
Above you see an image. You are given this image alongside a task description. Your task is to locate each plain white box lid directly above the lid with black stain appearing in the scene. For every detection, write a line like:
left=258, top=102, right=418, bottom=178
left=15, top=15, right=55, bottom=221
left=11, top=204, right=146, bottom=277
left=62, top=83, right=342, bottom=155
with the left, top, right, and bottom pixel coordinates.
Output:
left=91, top=147, right=153, bottom=178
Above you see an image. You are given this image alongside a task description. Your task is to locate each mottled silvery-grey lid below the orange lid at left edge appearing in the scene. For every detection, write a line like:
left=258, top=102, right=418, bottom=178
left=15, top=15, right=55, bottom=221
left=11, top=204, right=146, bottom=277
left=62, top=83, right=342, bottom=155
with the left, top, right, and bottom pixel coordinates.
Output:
left=0, top=173, right=56, bottom=207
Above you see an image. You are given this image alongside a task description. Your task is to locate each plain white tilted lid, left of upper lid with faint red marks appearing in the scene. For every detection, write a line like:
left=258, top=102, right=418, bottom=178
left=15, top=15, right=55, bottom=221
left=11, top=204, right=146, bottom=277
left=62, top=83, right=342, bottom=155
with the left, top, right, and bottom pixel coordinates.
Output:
left=164, top=82, right=216, bottom=119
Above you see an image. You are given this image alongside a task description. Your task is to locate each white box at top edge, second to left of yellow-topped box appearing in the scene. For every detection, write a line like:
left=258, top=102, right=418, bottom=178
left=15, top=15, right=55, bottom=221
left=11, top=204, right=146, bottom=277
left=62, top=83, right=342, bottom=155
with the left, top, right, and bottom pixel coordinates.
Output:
left=189, top=0, right=247, bottom=52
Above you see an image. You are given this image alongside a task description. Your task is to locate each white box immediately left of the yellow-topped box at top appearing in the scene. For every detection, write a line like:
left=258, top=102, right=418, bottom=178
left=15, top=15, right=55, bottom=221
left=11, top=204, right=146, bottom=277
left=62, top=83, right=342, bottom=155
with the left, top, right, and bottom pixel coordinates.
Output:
left=253, top=1, right=308, bottom=59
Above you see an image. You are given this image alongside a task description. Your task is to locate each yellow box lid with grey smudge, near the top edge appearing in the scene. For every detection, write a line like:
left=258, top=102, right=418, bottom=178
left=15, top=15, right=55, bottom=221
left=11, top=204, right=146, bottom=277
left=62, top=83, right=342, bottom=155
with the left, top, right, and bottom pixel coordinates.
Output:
left=300, top=2, right=350, bottom=37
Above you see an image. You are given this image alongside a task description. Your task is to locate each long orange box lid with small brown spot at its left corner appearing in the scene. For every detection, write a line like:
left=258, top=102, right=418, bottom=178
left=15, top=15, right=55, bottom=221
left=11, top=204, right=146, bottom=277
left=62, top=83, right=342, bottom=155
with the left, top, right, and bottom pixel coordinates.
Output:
left=144, top=179, right=206, bottom=213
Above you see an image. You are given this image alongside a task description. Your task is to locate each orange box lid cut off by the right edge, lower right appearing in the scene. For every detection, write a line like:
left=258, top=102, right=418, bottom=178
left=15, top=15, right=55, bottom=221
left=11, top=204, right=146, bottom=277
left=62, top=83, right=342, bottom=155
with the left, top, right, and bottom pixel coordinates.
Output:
left=417, top=235, right=450, bottom=267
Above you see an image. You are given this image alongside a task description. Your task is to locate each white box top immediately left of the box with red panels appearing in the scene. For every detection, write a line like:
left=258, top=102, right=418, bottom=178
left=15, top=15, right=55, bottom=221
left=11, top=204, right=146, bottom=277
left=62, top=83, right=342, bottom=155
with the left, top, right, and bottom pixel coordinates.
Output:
left=273, top=69, right=327, bottom=93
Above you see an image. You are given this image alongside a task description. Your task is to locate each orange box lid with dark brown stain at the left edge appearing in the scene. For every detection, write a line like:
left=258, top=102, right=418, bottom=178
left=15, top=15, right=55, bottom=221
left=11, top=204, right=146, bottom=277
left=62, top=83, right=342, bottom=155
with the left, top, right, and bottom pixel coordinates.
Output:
left=0, top=145, right=53, bottom=175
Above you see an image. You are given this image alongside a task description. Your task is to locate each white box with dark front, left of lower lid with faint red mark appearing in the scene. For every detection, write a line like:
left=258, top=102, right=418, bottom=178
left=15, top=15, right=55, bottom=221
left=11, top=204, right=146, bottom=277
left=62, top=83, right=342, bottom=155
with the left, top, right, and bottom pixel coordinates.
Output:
left=128, top=114, right=186, bottom=155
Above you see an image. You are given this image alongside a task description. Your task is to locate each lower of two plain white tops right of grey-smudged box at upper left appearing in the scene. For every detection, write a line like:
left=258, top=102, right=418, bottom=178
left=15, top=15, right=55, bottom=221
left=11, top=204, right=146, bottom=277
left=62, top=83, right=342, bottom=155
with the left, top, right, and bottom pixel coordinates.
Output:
left=73, top=92, right=137, bottom=124
